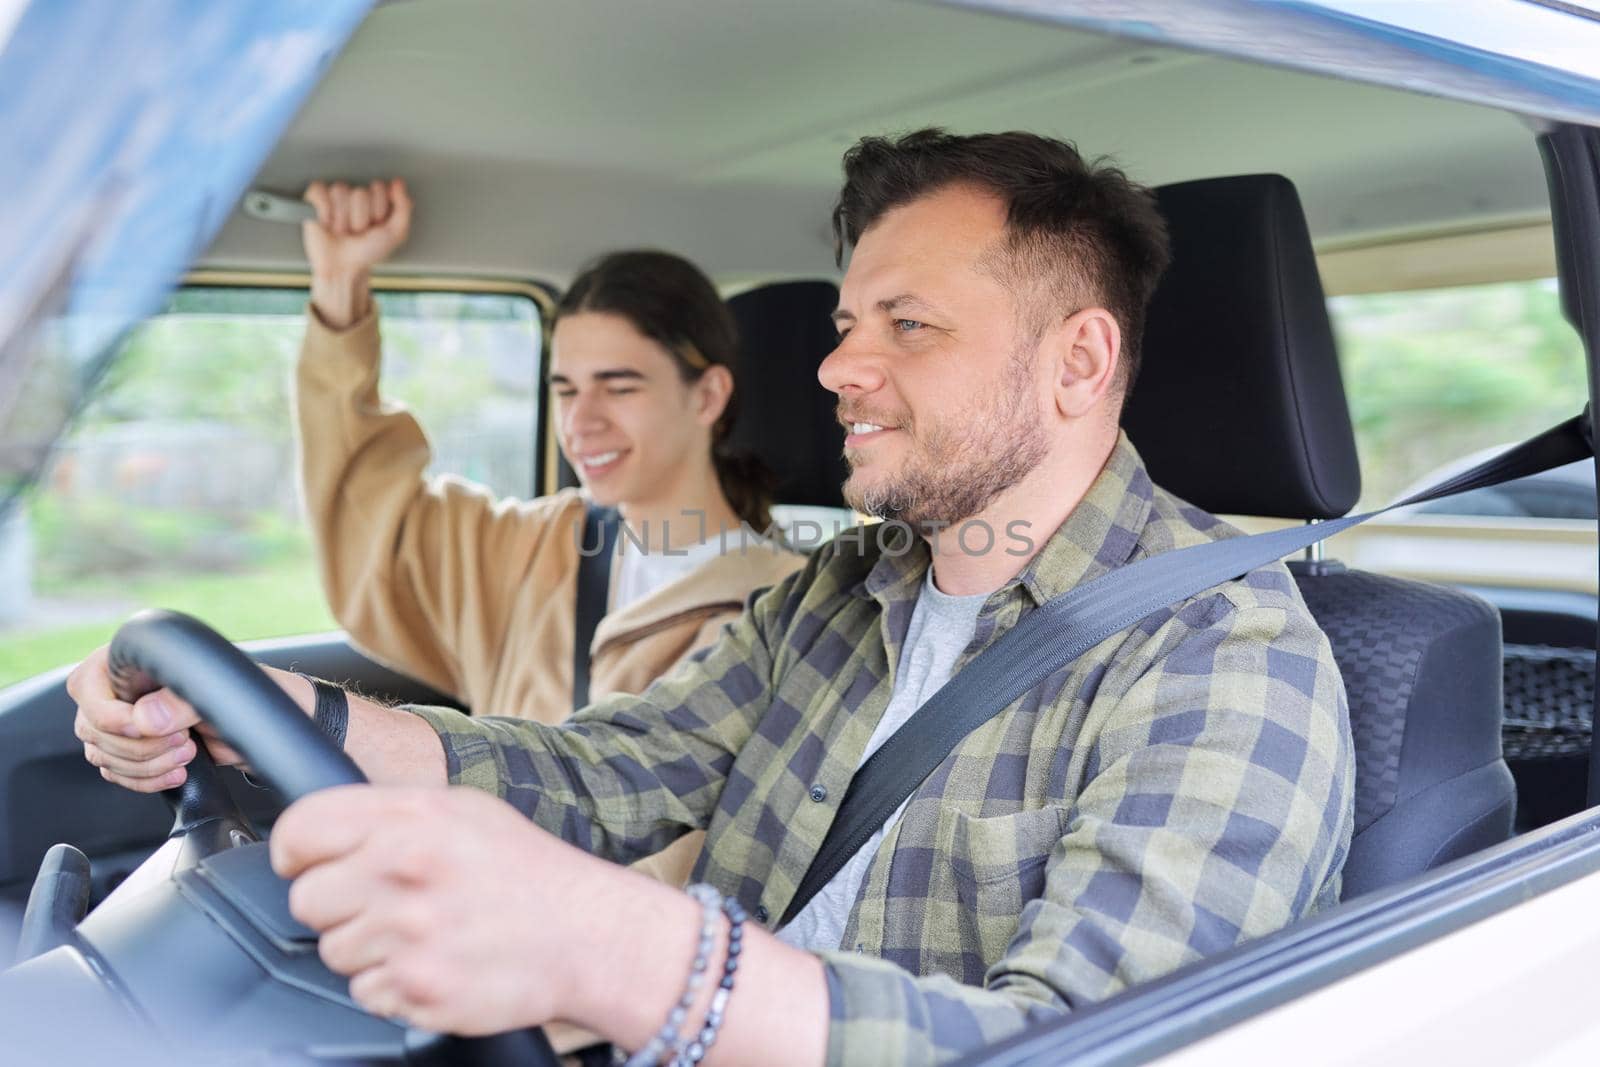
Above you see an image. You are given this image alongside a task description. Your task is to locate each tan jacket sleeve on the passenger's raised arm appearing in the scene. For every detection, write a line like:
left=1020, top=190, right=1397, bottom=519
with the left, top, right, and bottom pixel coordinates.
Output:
left=296, top=309, right=562, bottom=699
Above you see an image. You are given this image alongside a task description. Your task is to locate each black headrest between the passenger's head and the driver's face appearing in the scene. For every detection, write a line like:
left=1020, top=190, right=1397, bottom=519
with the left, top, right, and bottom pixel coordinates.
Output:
left=728, top=282, right=848, bottom=507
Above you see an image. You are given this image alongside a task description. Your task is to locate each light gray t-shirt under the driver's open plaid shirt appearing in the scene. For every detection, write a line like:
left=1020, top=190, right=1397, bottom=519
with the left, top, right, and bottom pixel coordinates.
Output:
left=778, top=566, right=989, bottom=950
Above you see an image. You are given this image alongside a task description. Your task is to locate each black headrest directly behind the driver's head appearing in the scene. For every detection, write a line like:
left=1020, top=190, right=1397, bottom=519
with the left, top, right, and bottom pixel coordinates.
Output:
left=1123, top=174, right=1362, bottom=518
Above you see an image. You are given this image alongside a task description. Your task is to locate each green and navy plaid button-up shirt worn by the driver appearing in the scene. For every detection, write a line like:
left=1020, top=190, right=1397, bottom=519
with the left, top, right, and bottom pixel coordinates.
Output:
left=416, top=437, right=1354, bottom=1064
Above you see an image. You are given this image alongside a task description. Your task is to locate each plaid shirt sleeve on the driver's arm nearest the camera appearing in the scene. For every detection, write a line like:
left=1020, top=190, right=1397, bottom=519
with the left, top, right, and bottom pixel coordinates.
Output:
left=821, top=597, right=1354, bottom=1067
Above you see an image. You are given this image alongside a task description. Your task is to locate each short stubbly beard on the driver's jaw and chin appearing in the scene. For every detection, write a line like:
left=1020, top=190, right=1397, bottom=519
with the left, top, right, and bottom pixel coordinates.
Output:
left=845, top=349, right=1050, bottom=526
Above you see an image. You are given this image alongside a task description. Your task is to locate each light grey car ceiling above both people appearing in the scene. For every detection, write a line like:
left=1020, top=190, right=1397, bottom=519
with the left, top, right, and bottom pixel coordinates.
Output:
left=203, top=0, right=1547, bottom=285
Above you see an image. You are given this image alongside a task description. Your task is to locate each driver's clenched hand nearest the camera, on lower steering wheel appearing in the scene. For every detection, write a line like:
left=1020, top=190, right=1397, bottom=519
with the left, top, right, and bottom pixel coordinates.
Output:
left=272, top=785, right=617, bottom=1035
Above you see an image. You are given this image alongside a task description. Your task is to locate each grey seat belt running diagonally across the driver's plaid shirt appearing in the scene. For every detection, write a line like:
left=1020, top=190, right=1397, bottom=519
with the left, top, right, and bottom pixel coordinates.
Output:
left=782, top=408, right=1594, bottom=923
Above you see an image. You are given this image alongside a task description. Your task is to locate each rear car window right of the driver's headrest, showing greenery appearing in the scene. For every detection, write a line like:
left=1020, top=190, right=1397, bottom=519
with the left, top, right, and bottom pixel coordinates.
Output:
left=1328, top=278, right=1595, bottom=520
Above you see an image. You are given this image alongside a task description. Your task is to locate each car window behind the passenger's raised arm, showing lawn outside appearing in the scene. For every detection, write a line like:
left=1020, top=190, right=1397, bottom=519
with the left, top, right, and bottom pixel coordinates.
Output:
left=0, top=286, right=541, bottom=685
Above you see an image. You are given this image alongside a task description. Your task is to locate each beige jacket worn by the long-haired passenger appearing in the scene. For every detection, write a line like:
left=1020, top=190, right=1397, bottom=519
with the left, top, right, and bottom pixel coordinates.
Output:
left=296, top=310, right=803, bottom=883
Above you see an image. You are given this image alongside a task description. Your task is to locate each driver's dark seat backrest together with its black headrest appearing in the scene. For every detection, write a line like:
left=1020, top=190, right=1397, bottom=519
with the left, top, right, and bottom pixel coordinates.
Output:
left=1123, top=174, right=1515, bottom=897
